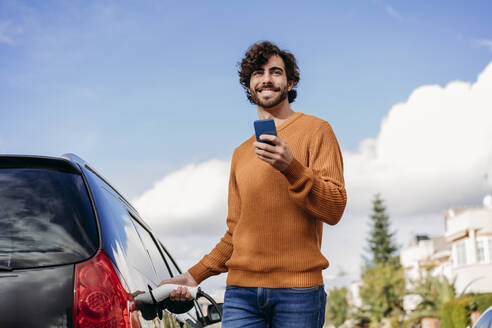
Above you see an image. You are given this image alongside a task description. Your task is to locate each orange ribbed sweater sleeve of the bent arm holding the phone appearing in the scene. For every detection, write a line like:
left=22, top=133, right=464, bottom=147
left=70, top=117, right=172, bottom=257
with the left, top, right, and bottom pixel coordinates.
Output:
left=282, top=122, right=347, bottom=225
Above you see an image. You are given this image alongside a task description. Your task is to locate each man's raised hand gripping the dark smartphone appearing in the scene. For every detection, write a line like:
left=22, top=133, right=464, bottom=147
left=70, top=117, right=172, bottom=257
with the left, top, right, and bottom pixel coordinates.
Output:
left=253, top=134, right=294, bottom=171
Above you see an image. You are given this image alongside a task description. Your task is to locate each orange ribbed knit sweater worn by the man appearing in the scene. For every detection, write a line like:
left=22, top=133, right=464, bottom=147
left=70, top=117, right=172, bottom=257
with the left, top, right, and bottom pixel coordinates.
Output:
left=188, top=112, right=347, bottom=288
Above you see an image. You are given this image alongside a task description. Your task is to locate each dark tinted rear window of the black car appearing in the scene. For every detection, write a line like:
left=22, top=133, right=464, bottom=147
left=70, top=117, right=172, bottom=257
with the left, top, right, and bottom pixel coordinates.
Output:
left=0, top=168, right=98, bottom=270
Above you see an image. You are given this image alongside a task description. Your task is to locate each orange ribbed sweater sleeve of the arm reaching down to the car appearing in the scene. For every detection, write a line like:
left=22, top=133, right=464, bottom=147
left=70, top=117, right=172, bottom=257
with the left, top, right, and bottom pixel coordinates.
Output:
left=188, top=152, right=241, bottom=284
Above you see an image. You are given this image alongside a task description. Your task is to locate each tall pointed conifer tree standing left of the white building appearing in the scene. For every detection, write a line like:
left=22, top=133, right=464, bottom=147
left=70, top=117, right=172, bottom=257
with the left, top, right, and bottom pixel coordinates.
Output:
left=367, top=194, right=397, bottom=264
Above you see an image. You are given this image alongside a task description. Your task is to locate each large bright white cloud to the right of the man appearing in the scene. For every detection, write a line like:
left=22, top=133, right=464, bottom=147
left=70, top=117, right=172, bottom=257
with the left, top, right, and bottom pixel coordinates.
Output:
left=344, top=63, right=492, bottom=215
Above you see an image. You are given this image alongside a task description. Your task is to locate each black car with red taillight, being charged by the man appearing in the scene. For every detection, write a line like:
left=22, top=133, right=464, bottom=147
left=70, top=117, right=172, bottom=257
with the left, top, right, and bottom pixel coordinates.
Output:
left=0, top=154, right=220, bottom=328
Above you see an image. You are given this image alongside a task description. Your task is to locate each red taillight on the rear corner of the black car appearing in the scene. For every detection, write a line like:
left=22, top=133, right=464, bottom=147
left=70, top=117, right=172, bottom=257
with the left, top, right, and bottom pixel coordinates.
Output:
left=74, top=251, right=132, bottom=328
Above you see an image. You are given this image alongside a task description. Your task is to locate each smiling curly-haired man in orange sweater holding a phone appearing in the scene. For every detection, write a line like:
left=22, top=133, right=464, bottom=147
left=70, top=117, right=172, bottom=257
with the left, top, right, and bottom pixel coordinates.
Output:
left=161, top=42, right=346, bottom=328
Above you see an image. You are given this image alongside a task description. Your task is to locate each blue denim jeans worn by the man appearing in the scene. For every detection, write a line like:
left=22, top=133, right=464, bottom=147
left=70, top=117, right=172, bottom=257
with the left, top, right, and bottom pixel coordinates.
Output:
left=222, top=286, right=326, bottom=328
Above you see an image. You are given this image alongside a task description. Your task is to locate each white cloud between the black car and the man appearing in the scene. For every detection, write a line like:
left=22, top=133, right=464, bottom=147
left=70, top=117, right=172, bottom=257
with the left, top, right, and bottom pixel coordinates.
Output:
left=133, top=159, right=229, bottom=233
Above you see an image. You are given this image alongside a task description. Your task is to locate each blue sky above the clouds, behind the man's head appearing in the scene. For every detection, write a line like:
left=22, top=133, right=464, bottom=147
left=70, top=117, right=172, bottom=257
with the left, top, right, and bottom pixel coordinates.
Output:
left=0, top=0, right=492, bottom=292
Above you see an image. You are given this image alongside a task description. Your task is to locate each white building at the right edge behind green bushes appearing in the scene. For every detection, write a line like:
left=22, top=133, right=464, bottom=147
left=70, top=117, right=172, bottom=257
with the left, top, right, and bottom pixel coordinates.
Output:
left=400, top=195, right=492, bottom=312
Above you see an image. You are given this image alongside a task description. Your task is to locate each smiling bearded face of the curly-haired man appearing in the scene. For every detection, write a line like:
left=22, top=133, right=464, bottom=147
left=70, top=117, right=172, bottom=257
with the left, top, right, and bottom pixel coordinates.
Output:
left=249, top=56, right=293, bottom=109
